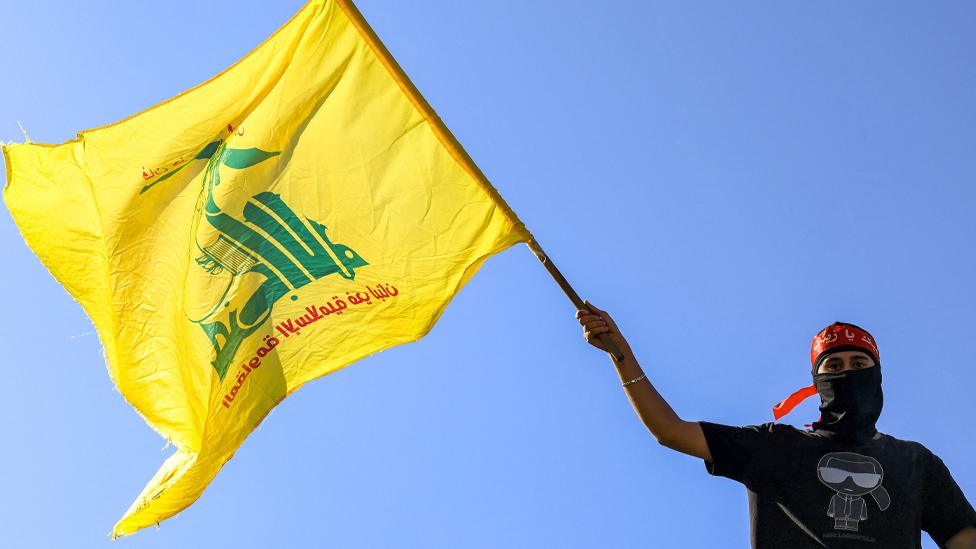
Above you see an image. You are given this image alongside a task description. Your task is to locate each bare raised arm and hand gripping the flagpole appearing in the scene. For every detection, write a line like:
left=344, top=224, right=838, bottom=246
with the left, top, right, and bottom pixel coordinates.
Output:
left=576, top=302, right=712, bottom=461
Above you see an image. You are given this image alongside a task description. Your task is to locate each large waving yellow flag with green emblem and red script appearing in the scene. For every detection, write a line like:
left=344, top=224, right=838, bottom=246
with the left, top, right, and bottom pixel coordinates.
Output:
left=4, top=0, right=530, bottom=535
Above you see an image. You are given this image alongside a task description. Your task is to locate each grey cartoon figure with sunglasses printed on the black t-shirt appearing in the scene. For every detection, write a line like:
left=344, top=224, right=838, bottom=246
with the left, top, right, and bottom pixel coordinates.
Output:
left=817, top=452, right=891, bottom=532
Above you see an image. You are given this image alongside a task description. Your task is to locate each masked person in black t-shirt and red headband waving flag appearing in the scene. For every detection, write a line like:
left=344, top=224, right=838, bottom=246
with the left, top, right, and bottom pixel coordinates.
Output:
left=576, top=302, right=976, bottom=549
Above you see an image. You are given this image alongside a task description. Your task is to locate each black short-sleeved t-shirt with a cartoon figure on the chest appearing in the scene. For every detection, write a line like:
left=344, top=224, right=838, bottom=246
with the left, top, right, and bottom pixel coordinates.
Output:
left=701, top=421, right=976, bottom=549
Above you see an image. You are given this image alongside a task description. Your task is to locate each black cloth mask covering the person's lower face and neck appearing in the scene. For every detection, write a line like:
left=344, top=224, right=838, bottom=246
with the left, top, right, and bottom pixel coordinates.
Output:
left=813, top=366, right=884, bottom=438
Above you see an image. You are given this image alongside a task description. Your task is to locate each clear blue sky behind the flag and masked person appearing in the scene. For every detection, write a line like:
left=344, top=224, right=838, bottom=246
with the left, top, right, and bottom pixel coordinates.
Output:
left=0, top=0, right=976, bottom=549
